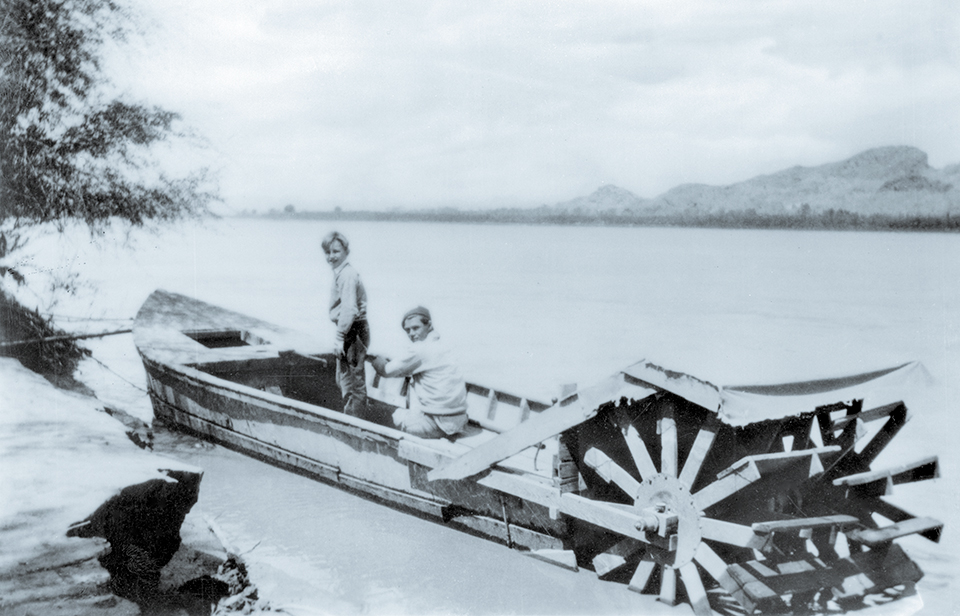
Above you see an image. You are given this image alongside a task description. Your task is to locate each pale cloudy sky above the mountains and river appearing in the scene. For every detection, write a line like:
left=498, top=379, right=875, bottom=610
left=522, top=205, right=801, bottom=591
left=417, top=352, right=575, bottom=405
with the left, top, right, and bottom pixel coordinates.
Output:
left=108, top=0, right=960, bottom=212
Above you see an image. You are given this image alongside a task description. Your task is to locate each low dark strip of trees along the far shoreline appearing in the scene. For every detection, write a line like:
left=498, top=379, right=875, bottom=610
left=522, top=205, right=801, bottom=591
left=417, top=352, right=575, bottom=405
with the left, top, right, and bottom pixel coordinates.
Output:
left=249, top=206, right=960, bottom=231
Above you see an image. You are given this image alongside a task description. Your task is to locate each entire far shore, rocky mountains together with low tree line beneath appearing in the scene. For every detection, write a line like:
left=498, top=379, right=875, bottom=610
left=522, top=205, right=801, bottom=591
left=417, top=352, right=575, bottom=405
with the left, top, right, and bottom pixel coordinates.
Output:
left=258, top=146, right=960, bottom=232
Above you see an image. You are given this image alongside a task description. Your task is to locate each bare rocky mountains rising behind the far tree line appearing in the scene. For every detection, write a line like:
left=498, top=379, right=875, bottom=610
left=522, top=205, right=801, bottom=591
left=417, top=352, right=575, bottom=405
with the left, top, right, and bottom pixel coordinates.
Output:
left=538, top=146, right=960, bottom=218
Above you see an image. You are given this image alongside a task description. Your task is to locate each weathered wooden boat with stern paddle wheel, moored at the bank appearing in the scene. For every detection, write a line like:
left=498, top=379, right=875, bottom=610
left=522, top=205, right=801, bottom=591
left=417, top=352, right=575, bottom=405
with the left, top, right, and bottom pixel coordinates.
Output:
left=134, top=291, right=942, bottom=614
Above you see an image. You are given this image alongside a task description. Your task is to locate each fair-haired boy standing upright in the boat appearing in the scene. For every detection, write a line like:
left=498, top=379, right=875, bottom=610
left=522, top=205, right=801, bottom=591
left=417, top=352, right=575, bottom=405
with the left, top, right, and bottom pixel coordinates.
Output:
left=321, top=231, right=370, bottom=417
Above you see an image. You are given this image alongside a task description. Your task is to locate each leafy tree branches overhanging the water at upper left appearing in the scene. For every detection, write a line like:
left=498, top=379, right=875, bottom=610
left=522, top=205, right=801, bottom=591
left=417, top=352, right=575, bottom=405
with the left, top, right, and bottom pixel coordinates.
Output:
left=0, top=0, right=216, bottom=256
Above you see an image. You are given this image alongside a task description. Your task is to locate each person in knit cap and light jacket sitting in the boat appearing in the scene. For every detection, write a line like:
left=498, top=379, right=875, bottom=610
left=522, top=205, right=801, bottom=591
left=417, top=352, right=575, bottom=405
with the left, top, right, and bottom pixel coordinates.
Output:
left=370, top=306, right=467, bottom=438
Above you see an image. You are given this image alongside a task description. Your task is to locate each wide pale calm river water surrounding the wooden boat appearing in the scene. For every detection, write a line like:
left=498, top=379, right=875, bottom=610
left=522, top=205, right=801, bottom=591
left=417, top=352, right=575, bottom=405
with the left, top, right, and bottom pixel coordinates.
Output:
left=21, top=219, right=960, bottom=614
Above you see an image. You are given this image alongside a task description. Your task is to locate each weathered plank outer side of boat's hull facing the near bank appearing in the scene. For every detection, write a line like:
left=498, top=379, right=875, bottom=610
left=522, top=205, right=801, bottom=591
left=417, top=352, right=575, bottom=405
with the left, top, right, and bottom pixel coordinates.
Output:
left=144, top=348, right=567, bottom=550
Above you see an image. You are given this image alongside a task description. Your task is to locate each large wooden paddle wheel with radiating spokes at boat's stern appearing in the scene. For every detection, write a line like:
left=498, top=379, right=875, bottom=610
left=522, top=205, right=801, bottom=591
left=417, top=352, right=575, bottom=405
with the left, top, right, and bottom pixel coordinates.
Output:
left=556, top=384, right=942, bottom=615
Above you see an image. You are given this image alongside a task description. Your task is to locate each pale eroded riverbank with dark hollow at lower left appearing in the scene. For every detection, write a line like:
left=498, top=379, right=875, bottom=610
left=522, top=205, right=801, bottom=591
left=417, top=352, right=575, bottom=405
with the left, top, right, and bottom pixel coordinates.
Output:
left=0, top=358, right=271, bottom=616
